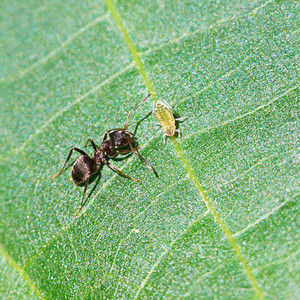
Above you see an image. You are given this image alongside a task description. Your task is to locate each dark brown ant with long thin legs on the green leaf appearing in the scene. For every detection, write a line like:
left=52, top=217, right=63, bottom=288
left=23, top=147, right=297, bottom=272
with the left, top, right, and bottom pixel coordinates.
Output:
left=52, top=93, right=153, bottom=217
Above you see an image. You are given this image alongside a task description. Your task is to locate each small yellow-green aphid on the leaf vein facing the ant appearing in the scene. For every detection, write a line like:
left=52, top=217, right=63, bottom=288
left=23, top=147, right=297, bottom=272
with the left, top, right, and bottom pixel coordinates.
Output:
left=152, top=100, right=185, bottom=144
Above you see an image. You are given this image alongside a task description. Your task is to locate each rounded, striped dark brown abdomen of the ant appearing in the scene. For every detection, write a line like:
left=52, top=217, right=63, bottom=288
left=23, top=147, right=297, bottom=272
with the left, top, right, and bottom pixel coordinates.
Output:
left=72, top=155, right=98, bottom=185
